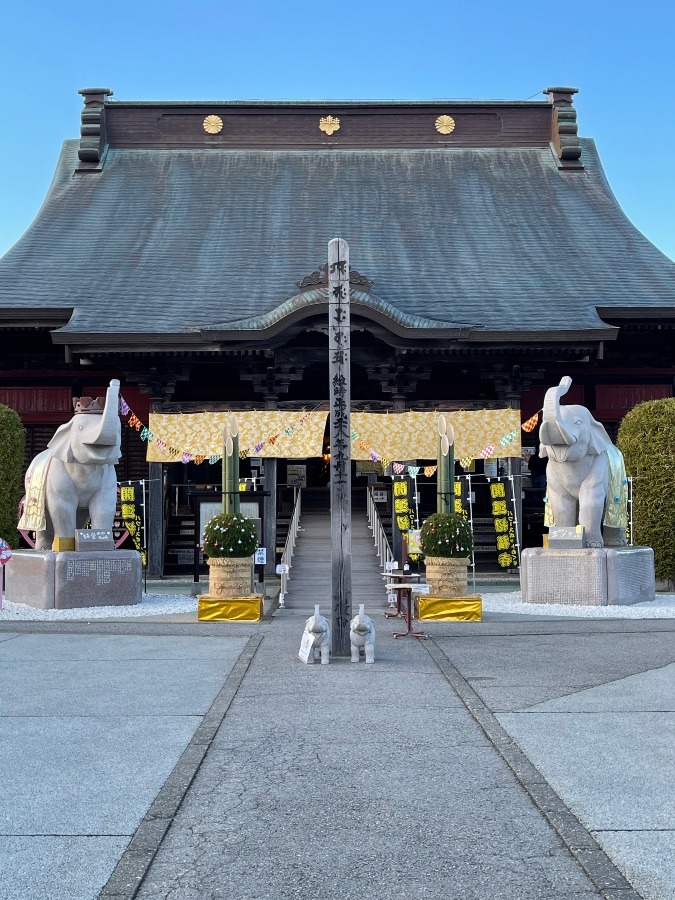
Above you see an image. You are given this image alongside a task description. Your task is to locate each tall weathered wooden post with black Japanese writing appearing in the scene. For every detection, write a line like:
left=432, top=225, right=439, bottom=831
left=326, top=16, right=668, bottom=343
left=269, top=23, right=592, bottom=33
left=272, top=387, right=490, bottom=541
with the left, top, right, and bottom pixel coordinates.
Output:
left=328, top=238, right=352, bottom=656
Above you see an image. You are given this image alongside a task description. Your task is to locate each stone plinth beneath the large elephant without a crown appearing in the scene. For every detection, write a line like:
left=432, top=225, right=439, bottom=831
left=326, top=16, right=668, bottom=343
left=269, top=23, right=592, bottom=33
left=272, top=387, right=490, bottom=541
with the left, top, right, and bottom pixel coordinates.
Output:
left=520, top=547, right=655, bottom=606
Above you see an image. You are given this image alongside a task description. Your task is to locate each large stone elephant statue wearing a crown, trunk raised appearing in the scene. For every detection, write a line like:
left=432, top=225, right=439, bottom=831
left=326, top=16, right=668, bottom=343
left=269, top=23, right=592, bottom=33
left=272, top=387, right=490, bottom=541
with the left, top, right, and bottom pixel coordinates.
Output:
left=19, top=379, right=122, bottom=550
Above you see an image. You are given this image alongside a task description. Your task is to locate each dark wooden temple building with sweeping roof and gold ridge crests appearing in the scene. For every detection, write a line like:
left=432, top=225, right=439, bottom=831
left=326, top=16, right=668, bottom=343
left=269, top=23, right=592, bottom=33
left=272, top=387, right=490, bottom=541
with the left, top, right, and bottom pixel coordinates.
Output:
left=0, top=87, right=675, bottom=573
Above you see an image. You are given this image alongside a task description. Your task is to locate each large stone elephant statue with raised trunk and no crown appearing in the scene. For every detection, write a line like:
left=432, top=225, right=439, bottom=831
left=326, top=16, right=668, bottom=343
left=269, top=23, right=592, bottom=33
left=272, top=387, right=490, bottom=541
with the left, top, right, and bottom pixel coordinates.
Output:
left=539, top=375, right=627, bottom=547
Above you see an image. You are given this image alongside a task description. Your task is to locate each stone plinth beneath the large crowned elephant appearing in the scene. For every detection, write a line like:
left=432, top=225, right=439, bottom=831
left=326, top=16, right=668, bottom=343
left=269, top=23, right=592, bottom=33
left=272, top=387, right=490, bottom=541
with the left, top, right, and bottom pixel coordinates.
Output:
left=5, top=550, right=142, bottom=609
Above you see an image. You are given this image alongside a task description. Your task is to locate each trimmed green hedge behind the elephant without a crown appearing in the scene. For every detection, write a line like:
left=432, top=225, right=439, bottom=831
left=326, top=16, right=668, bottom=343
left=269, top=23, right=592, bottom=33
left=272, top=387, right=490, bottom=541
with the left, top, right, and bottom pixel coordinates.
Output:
left=617, top=398, right=675, bottom=579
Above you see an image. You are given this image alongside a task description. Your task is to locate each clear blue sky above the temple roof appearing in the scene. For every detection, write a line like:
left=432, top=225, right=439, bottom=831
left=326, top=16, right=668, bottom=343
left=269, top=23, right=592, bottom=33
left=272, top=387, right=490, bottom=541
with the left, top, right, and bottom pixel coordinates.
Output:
left=0, top=0, right=675, bottom=259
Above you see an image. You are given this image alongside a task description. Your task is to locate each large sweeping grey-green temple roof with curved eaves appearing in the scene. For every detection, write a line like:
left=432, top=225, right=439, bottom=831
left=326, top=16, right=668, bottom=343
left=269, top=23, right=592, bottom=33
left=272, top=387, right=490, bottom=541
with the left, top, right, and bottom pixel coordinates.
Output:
left=0, top=89, right=675, bottom=344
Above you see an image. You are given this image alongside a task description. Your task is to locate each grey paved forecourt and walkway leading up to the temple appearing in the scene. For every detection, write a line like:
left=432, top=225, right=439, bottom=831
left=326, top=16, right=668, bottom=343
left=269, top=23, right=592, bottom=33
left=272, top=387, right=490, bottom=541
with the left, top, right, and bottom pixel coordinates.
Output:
left=0, top=517, right=675, bottom=900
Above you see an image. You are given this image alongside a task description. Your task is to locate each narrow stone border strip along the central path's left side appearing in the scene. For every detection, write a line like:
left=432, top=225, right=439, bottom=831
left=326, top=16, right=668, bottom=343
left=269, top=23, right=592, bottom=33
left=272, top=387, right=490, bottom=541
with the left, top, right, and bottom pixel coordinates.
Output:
left=98, top=634, right=264, bottom=900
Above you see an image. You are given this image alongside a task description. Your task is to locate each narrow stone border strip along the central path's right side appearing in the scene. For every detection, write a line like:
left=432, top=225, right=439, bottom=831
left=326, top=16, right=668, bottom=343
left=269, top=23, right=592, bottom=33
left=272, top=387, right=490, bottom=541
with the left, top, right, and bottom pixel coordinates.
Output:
left=422, top=638, right=644, bottom=900
